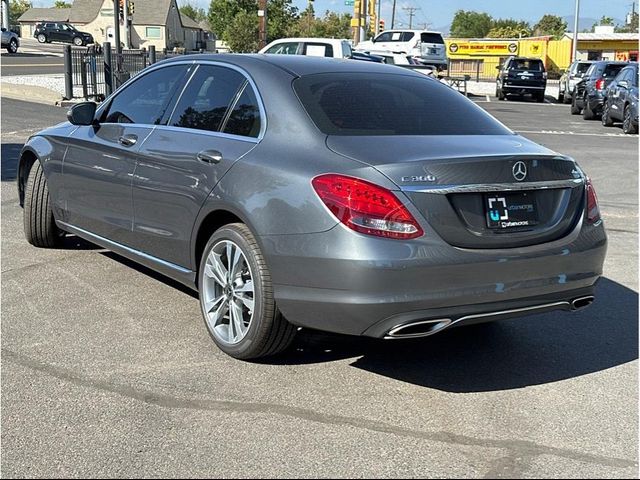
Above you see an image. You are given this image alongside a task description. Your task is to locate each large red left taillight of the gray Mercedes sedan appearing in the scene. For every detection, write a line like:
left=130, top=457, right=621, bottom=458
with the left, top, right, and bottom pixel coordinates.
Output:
left=311, top=174, right=424, bottom=239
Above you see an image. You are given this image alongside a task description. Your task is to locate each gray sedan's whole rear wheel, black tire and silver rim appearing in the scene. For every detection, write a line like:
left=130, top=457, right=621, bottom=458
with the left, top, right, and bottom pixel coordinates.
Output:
left=198, top=223, right=296, bottom=360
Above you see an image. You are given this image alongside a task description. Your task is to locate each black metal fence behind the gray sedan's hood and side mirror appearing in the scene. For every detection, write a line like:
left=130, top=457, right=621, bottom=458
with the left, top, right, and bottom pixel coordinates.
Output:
left=64, top=42, right=185, bottom=101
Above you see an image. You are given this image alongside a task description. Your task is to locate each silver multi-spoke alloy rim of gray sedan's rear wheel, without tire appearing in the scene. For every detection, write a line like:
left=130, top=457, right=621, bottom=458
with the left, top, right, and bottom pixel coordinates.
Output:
left=201, top=240, right=255, bottom=345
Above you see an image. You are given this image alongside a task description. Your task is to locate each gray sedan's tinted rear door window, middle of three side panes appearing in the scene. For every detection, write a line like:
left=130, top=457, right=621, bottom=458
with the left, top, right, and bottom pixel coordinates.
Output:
left=171, top=65, right=245, bottom=132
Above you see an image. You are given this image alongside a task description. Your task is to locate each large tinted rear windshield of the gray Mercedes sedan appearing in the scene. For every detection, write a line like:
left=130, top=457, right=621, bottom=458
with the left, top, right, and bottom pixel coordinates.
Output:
left=293, top=73, right=511, bottom=136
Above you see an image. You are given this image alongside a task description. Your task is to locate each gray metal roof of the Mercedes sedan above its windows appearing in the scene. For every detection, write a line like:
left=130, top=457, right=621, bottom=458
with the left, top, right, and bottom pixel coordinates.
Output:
left=162, top=53, right=424, bottom=77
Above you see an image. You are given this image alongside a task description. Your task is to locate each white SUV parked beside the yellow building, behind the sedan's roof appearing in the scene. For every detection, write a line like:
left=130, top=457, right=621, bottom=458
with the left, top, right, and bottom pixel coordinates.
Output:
left=355, top=30, right=447, bottom=70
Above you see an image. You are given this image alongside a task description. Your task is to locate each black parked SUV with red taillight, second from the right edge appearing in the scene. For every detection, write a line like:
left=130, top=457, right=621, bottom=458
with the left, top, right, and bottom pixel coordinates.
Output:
left=571, top=60, right=628, bottom=120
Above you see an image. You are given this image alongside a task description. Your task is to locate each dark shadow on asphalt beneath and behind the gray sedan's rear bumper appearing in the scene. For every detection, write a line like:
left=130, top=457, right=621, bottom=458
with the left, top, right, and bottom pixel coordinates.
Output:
left=274, top=278, right=638, bottom=393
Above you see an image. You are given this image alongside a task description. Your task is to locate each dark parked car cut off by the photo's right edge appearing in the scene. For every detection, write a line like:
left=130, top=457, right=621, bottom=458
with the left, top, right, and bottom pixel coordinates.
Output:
left=602, top=62, right=638, bottom=133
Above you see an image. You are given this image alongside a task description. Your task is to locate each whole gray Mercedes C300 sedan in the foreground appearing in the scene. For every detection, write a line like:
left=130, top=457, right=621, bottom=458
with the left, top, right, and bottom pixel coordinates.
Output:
left=17, top=55, right=607, bottom=359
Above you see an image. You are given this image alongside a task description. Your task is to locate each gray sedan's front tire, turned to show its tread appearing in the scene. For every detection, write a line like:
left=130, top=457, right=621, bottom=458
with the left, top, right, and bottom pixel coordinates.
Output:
left=23, top=160, right=64, bottom=248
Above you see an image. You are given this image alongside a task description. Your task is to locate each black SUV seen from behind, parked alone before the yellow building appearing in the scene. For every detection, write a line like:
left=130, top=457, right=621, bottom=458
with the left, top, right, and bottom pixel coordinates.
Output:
left=496, top=57, right=547, bottom=102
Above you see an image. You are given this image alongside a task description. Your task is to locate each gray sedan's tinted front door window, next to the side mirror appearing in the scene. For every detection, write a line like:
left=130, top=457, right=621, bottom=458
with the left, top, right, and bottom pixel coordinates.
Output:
left=102, top=65, right=187, bottom=125
